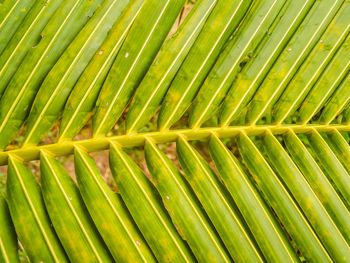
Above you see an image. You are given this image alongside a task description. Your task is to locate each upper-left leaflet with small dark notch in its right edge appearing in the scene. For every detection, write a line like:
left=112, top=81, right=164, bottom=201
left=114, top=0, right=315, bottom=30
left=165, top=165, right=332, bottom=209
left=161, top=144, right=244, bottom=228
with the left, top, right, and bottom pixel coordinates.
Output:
left=0, top=0, right=63, bottom=97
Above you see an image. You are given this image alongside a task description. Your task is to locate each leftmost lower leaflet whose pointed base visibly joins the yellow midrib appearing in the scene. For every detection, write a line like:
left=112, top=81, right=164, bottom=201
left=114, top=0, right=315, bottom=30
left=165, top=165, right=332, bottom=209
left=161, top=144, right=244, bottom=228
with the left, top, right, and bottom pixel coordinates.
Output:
left=7, top=157, right=68, bottom=262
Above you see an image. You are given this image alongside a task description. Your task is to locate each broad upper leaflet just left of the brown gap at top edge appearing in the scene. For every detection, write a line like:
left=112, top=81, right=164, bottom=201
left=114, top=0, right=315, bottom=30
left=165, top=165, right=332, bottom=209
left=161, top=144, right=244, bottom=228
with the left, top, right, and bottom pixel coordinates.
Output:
left=93, top=0, right=185, bottom=137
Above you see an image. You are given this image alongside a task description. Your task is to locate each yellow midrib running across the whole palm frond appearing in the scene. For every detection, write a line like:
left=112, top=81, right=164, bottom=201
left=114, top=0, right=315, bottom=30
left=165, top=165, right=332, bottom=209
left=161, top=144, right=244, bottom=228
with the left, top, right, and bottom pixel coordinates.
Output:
left=0, top=123, right=350, bottom=166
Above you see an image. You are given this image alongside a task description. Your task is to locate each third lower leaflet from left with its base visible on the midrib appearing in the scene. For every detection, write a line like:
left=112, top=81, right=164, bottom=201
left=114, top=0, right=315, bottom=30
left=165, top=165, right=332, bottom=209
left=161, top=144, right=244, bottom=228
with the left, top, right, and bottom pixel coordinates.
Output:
left=74, top=148, right=155, bottom=262
